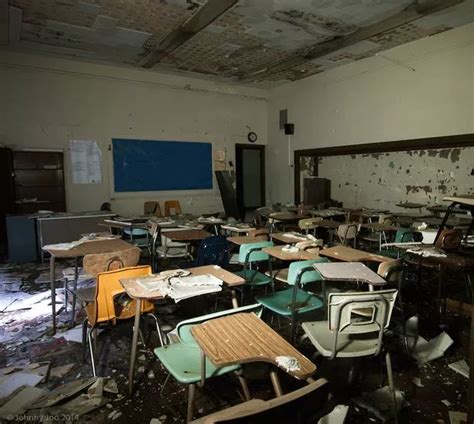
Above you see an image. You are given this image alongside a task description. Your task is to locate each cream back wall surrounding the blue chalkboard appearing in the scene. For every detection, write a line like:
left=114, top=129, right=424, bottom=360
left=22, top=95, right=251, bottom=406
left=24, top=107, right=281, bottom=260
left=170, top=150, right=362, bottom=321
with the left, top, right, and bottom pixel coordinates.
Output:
left=0, top=51, right=267, bottom=214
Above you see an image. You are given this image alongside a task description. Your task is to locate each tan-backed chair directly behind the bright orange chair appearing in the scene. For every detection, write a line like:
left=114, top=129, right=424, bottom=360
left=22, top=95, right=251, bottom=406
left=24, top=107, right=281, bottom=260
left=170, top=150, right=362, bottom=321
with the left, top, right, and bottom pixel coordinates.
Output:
left=65, top=247, right=140, bottom=324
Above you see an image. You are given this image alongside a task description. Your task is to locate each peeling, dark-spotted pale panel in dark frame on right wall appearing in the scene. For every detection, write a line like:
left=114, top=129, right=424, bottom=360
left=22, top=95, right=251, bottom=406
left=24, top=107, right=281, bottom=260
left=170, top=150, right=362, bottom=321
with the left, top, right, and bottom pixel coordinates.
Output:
left=318, top=147, right=474, bottom=210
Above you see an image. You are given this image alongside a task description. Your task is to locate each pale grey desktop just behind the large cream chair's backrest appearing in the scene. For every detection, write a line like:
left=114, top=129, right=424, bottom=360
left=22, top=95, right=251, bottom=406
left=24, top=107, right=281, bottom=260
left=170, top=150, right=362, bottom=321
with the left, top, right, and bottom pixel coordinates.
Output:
left=313, top=262, right=386, bottom=291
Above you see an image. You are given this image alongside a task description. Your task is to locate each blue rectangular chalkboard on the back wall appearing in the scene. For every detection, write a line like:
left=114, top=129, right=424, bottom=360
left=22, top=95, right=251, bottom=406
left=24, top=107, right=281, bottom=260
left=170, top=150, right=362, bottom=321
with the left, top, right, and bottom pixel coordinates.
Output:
left=112, top=138, right=212, bottom=192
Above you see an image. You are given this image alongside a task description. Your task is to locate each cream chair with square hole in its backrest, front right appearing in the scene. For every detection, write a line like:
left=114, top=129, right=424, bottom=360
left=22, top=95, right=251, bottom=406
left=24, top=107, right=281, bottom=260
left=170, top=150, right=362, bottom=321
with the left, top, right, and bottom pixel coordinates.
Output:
left=302, top=289, right=397, bottom=420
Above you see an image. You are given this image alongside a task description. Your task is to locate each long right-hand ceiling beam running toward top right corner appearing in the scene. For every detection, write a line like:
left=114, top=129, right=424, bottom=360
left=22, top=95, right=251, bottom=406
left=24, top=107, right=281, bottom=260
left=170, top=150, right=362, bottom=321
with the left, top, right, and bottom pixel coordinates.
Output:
left=239, top=0, right=464, bottom=82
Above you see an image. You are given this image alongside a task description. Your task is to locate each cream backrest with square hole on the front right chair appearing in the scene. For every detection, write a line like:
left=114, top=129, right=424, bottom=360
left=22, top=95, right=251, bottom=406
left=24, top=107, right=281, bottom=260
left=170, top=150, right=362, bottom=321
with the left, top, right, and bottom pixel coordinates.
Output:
left=328, top=289, right=398, bottom=358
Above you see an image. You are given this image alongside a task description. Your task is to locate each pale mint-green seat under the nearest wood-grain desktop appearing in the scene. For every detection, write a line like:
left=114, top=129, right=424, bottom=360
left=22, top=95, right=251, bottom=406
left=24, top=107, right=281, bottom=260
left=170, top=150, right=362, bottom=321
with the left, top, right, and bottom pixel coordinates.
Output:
left=153, top=343, right=240, bottom=384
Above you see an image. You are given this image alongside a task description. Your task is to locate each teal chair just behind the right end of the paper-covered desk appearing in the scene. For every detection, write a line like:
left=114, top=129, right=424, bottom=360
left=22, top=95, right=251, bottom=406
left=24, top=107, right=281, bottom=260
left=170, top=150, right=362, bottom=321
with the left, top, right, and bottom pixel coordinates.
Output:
left=235, top=241, right=273, bottom=303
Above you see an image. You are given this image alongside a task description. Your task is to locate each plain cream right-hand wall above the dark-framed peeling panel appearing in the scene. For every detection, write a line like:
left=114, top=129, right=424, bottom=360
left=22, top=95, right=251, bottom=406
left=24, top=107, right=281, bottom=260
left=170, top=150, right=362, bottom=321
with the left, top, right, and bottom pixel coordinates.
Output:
left=267, top=24, right=474, bottom=202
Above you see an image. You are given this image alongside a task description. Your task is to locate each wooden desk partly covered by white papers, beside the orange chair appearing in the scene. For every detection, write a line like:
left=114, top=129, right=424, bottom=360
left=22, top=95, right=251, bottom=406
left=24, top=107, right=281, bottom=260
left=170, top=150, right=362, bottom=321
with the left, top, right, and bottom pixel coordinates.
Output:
left=120, top=265, right=245, bottom=394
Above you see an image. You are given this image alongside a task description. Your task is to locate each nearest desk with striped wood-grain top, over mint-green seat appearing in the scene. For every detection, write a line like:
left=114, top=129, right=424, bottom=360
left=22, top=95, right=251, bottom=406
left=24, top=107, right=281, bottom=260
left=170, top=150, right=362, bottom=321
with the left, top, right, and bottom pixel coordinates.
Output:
left=191, top=313, right=316, bottom=396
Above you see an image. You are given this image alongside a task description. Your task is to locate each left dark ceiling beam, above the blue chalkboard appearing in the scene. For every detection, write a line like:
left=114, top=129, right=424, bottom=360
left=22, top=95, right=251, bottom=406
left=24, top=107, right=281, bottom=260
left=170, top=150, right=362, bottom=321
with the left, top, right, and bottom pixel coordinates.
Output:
left=138, top=0, right=238, bottom=68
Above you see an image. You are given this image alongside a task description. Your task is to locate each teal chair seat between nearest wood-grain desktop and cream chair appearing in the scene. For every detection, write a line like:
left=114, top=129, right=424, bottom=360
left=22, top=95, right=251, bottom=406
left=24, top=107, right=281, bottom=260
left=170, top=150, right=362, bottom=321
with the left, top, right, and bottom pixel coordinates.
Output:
left=256, top=288, right=324, bottom=316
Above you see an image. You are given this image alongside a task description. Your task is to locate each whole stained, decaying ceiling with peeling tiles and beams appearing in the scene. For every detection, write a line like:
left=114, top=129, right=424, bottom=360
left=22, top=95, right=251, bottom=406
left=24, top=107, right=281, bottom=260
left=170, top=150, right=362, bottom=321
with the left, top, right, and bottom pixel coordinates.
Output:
left=0, top=0, right=474, bottom=84
